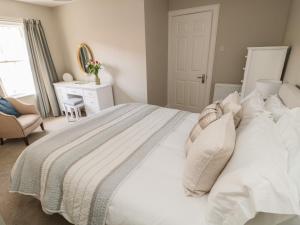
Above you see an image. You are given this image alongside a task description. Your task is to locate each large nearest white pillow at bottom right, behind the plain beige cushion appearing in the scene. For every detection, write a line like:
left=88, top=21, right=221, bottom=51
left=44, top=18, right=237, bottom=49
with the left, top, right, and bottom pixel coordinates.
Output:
left=206, top=115, right=300, bottom=225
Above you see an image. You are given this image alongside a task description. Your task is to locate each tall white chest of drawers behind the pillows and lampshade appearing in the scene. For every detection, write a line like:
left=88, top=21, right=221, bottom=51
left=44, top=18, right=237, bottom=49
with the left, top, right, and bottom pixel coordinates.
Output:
left=241, top=46, right=288, bottom=98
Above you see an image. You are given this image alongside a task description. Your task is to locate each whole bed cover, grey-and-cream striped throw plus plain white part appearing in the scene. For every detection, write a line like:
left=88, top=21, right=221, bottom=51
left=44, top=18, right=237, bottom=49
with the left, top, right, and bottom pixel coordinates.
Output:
left=10, top=83, right=300, bottom=225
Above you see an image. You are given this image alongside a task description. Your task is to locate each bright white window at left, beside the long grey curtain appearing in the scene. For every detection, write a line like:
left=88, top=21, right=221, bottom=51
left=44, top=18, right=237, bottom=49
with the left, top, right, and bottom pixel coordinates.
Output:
left=0, top=22, right=35, bottom=97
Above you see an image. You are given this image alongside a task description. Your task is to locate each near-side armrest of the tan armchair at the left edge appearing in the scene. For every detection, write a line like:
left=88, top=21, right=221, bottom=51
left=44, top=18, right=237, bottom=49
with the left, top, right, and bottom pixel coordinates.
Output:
left=0, top=112, right=24, bottom=138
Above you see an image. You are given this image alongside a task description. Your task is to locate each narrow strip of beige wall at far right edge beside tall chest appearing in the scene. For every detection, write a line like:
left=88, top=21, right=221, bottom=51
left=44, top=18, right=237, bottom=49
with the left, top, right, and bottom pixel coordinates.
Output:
left=284, top=0, right=300, bottom=84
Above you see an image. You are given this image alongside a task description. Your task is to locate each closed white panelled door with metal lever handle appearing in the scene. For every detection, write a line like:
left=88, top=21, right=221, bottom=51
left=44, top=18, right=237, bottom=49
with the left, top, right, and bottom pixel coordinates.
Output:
left=169, top=5, right=216, bottom=112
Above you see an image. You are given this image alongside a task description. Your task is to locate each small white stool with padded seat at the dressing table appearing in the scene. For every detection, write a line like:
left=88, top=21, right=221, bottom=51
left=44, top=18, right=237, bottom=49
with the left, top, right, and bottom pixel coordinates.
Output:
left=64, top=98, right=84, bottom=121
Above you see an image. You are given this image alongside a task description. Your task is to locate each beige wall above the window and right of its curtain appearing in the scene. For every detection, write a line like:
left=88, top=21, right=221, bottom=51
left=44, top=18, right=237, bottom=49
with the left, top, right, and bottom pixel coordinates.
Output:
left=0, top=0, right=65, bottom=75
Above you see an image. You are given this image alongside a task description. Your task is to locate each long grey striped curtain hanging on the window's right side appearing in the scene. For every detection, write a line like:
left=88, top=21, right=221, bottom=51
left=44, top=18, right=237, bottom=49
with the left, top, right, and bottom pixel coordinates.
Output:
left=24, top=19, right=60, bottom=118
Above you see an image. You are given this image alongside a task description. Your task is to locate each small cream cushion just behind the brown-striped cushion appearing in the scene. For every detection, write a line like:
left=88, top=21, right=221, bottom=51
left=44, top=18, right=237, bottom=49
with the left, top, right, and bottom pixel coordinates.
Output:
left=222, top=91, right=242, bottom=127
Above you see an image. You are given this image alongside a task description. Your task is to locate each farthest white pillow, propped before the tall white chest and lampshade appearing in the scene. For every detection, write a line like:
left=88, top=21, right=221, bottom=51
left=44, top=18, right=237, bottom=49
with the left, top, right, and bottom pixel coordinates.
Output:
left=241, top=90, right=271, bottom=121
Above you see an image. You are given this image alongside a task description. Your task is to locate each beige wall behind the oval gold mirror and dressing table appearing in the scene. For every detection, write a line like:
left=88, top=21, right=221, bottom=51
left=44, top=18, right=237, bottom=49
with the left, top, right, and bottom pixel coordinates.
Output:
left=53, top=0, right=147, bottom=104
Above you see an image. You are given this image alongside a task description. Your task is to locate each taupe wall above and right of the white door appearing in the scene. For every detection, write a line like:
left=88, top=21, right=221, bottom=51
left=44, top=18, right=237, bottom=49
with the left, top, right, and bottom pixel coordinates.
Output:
left=169, top=0, right=291, bottom=98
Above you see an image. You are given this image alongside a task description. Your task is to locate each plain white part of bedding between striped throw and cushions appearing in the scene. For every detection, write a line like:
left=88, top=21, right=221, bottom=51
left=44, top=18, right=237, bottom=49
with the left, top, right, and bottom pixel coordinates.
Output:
left=107, top=114, right=207, bottom=225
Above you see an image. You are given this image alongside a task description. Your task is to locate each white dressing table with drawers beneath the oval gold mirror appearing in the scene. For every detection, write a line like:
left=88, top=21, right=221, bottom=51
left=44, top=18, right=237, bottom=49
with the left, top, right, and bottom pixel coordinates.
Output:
left=54, top=81, right=114, bottom=116
